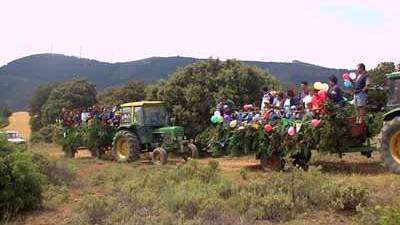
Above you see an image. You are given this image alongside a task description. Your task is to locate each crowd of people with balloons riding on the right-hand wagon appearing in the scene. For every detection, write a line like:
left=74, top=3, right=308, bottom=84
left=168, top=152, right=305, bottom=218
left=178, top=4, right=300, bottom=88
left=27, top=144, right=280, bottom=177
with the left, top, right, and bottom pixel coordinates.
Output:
left=216, top=64, right=371, bottom=123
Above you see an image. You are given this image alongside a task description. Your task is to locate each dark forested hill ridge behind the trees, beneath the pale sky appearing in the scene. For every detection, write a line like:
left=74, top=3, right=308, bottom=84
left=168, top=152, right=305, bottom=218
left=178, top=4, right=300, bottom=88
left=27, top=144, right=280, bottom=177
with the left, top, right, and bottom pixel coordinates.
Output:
left=0, top=54, right=343, bottom=110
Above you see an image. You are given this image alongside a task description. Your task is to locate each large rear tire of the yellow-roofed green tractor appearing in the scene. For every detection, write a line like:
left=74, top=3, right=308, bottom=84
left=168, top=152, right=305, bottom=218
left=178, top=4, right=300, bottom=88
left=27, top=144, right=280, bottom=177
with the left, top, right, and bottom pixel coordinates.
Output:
left=111, top=130, right=140, bottom=162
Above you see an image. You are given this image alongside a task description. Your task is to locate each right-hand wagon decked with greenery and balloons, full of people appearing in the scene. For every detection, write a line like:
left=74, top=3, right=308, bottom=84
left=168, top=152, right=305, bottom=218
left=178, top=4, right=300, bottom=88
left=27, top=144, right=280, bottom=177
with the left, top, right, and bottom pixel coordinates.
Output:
left=205, top=64, right=375, bottom=169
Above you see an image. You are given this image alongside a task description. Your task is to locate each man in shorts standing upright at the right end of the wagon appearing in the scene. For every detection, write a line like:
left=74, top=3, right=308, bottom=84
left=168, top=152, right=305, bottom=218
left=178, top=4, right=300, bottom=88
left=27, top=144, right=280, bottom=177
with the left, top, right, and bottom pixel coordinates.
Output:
left=352, top=63, right=371, bottom=124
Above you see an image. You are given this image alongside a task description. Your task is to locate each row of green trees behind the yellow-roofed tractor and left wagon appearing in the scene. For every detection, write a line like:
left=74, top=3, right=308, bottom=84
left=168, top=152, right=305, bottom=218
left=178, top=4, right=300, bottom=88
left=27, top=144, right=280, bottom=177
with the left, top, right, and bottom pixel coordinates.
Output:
left=29, top=59, right=278, bottom=137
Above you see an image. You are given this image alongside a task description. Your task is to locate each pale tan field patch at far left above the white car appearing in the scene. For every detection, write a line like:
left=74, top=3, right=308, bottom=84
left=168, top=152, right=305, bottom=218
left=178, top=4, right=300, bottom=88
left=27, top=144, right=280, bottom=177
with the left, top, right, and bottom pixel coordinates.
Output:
left=4, top=112, right=31, bottom=140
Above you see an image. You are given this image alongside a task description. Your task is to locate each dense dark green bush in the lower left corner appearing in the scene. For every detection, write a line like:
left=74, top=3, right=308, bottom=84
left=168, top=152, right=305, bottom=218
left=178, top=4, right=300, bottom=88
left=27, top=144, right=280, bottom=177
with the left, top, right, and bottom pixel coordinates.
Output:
left=0, top=140, right=44, bottom=221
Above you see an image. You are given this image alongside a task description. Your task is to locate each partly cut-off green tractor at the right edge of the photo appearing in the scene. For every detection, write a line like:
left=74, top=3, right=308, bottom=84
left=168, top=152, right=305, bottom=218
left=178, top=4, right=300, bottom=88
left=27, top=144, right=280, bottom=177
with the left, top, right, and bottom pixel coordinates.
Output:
left=378, top=72, right=400, bottom=174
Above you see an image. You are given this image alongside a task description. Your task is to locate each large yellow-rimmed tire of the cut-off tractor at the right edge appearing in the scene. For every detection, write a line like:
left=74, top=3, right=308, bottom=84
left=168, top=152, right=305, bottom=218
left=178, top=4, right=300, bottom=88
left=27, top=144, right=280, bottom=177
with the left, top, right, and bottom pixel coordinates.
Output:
left=378, top=117, right=400, bottom=174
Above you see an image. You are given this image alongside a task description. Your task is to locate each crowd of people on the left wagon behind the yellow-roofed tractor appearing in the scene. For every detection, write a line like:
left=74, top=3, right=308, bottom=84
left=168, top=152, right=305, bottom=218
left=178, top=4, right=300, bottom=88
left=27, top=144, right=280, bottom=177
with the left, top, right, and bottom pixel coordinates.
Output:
left=57, top=106, right=120, bottom=127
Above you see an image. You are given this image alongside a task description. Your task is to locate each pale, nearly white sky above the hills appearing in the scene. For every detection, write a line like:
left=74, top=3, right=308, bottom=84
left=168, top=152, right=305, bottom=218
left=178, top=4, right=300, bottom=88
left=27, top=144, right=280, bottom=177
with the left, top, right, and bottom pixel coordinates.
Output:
left=0, top=0, right=400, bottom=68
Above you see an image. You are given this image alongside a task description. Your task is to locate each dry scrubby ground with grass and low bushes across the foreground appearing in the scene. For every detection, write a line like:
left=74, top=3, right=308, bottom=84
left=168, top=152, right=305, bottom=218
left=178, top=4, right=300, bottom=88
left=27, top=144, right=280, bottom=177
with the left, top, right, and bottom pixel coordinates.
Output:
left=5, top=144, right=400, bottom=225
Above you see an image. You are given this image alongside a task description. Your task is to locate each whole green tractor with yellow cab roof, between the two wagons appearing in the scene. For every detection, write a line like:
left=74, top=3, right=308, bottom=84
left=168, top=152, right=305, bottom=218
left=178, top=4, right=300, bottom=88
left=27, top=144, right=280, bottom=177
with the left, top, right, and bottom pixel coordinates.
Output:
left=112, top=101, right=199, bottom=165
